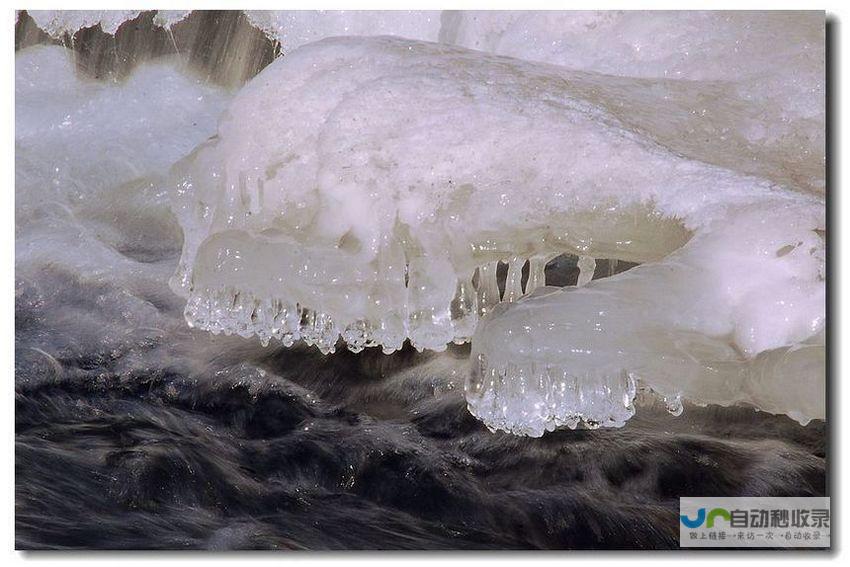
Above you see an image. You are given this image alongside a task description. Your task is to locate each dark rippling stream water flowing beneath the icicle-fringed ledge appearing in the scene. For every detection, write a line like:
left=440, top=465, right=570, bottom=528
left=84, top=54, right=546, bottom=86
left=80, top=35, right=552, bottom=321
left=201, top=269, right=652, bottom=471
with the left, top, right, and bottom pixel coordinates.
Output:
left=15, top=267, right=826, bottom=549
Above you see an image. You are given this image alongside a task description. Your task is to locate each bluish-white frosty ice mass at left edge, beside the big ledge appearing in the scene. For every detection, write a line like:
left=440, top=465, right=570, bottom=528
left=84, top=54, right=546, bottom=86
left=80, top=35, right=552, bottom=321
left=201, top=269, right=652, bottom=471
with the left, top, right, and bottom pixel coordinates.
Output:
left=15, top=45, right=228, bottom=385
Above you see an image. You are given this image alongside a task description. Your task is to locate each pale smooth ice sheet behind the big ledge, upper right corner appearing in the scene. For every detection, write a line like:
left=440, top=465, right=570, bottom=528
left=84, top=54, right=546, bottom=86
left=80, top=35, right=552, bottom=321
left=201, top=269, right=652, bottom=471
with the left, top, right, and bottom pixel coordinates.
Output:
left=448, top=10, right=826, bottom=192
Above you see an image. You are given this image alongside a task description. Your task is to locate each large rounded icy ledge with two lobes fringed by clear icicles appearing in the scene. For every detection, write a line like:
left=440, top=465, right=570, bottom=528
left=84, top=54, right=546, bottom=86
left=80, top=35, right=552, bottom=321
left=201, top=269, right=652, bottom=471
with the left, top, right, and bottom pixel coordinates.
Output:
left=166, top=38, right=824, bottom=435
